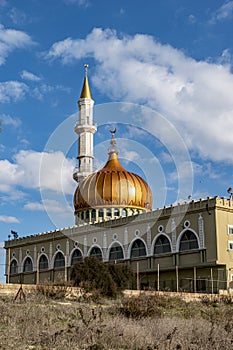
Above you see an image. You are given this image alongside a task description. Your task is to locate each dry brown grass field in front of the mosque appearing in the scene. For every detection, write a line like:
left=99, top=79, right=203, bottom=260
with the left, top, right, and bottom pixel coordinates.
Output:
left=0, top=294, right=233, bottom=350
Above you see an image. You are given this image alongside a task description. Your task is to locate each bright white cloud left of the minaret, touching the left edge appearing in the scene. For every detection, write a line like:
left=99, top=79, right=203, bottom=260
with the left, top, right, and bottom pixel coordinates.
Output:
left=0, top=150, right=75, bottom=194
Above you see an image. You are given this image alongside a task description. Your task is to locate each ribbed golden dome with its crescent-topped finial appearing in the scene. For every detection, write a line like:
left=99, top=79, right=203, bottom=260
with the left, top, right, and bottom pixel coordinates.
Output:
left=74, top=133, right=152, bottom=214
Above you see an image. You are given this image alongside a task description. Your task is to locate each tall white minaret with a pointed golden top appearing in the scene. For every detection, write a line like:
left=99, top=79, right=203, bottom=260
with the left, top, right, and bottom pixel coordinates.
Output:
left=73, top=64, right=97, bottom=182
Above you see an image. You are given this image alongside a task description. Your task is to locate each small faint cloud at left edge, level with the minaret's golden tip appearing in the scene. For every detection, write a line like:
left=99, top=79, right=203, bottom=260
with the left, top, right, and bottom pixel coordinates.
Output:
left=0, top=81, right=28, bottom=103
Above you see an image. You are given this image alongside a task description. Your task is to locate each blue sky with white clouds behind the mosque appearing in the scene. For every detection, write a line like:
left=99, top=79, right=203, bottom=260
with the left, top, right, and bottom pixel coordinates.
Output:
left=0, top=0, right=233, bottom=280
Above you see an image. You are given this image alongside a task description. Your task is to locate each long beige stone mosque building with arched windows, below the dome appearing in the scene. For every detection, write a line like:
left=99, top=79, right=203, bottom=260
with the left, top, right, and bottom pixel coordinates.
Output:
left=5, top=197, right=233, bottom=293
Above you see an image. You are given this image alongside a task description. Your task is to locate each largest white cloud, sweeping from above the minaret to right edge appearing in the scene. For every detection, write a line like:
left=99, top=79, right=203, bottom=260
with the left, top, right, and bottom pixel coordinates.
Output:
left=47, top=28, right=233, bottom=161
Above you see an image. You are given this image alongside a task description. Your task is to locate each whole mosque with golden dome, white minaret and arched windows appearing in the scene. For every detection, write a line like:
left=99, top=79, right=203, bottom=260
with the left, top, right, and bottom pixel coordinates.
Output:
left=5, top=65, right=233, bottom=293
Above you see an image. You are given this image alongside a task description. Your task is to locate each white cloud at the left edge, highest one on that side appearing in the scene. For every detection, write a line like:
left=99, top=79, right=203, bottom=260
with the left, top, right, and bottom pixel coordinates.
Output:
left=0, top=24, right=33, bottom=65
